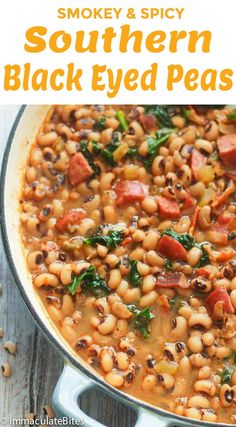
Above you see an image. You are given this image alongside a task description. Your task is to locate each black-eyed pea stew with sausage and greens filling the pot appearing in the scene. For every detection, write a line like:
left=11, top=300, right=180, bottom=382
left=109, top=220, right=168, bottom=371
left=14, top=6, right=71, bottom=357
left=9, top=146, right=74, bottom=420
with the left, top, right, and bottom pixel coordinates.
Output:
left=20, top=105, right=236, bottom=423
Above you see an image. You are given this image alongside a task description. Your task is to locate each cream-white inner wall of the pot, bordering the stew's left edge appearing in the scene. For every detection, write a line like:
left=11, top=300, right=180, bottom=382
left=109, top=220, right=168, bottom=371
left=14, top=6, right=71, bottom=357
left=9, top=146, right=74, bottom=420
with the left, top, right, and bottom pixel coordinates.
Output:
left=4, top=106, right=87, bottom=364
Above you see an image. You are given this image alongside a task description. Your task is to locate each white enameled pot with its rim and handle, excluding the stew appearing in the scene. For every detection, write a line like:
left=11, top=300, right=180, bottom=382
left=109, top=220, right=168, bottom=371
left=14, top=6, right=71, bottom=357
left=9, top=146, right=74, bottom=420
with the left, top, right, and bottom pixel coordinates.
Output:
left=0, top=106, right=232, bottom=427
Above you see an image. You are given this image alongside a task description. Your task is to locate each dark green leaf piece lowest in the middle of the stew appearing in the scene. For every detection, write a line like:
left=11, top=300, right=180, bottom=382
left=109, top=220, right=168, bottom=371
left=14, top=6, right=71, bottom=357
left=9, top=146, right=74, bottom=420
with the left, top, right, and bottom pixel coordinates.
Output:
left=127, top=305, right=155, bottom=338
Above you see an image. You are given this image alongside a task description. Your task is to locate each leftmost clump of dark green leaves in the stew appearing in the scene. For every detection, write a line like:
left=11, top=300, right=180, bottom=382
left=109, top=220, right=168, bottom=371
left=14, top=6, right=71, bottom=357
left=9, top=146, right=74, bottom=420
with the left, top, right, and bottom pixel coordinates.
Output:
left=68, top=265, right=110, bottom=297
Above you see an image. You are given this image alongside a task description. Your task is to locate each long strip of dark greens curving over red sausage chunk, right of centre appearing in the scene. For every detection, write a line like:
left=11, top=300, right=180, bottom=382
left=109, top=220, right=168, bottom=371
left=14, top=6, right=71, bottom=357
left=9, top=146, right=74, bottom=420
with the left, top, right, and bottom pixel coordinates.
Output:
left=161, top=228, right=210, bottom=268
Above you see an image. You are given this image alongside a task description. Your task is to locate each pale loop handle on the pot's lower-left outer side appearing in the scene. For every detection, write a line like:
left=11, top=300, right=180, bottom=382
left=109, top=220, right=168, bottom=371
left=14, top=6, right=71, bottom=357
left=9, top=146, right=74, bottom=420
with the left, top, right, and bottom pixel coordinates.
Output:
left=52, top=363, right=181, bottom=427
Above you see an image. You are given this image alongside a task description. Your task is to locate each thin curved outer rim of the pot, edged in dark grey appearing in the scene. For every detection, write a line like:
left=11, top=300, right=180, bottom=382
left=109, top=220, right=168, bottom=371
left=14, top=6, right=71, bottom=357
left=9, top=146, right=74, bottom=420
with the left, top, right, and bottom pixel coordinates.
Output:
left=0, top=105, right=232, bottom=427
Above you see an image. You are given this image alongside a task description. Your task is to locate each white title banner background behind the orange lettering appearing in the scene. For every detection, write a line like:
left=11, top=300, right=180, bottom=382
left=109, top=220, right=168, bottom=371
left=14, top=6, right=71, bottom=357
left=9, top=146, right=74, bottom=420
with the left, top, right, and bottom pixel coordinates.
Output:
left=0, top=0, right=236, bottom=104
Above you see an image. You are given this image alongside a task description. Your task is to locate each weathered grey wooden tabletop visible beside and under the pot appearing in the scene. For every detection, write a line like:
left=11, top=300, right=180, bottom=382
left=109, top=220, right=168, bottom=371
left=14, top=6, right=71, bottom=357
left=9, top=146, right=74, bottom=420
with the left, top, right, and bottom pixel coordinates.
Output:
left=0, top=105, right=136, bottom=427
